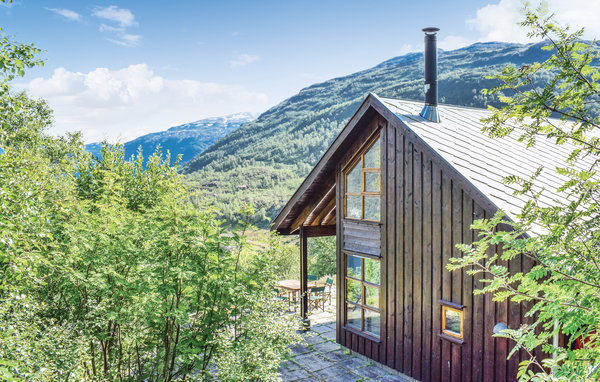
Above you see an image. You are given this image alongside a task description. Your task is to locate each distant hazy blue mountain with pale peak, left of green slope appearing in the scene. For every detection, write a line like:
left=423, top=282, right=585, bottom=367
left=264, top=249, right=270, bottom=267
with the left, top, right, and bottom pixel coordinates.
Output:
left=85, top=113, right=256, bottom=164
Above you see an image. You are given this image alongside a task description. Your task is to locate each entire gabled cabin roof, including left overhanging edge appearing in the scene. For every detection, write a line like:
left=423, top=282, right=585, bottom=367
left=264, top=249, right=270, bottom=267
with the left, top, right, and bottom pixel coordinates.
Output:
left=273, top=94, right=593, bottom=235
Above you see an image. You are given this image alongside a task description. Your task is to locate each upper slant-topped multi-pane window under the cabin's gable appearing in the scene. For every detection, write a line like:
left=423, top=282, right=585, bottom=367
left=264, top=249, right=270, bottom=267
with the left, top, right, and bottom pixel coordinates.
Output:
left=342, top=135, right=383, bottom=223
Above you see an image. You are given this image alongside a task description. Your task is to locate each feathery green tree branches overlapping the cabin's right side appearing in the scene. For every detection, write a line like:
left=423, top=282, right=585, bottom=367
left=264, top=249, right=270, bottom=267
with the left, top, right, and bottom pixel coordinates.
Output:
left=448, top=5, right=600, bottom=381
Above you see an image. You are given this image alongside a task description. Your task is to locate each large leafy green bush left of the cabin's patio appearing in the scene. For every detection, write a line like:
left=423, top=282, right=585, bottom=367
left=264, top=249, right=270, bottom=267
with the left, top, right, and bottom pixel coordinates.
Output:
left=1, top=137, right=295, bottom=380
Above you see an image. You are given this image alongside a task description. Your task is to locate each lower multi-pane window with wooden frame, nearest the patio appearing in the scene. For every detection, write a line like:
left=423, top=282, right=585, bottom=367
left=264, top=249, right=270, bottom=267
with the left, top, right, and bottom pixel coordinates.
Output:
left=342, top=251, right=381, bottom=341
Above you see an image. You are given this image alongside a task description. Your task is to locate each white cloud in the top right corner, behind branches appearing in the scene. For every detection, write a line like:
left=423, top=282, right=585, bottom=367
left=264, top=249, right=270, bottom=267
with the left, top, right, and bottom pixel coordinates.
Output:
left=467, top=0, right=600, bottom=43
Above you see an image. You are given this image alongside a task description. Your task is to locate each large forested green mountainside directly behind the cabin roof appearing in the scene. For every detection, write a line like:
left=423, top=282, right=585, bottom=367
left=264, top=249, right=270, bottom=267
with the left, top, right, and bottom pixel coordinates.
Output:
left=182, top=42, right=564, bottom=227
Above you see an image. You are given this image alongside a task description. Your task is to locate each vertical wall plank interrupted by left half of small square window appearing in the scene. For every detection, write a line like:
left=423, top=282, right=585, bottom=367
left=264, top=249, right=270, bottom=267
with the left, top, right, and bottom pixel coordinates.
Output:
left=436, top=173, right=452, bottom=381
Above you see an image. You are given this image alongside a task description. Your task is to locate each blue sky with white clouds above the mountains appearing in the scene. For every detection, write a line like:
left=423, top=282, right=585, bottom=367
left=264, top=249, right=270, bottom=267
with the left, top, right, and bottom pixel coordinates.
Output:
left=0, top=0, right=600, bottom=143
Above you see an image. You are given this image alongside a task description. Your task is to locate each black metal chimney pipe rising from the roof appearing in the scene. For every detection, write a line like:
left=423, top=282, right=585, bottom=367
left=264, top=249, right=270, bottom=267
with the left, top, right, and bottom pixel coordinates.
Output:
left=420, top=28, right=440, bottom=122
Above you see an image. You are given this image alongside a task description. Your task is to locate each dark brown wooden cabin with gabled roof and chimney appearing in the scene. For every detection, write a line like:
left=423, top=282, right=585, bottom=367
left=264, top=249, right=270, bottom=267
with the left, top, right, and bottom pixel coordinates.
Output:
left=273, top=30, right=584, bottom=382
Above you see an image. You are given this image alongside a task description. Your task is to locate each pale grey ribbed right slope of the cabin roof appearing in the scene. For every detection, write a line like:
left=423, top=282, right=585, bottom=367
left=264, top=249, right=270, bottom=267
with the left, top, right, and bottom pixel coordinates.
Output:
left=376, top=96, right=593, bottom=233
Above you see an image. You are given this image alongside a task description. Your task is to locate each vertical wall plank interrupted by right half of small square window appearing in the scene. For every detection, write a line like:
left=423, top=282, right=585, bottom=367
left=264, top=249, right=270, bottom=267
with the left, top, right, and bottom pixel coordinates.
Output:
left=444, top=182, right=464, bottom=382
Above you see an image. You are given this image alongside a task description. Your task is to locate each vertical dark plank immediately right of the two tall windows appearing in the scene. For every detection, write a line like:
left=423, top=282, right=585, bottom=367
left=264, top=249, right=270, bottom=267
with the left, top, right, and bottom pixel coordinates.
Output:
left=384, top=124, right=397, bottom=368
